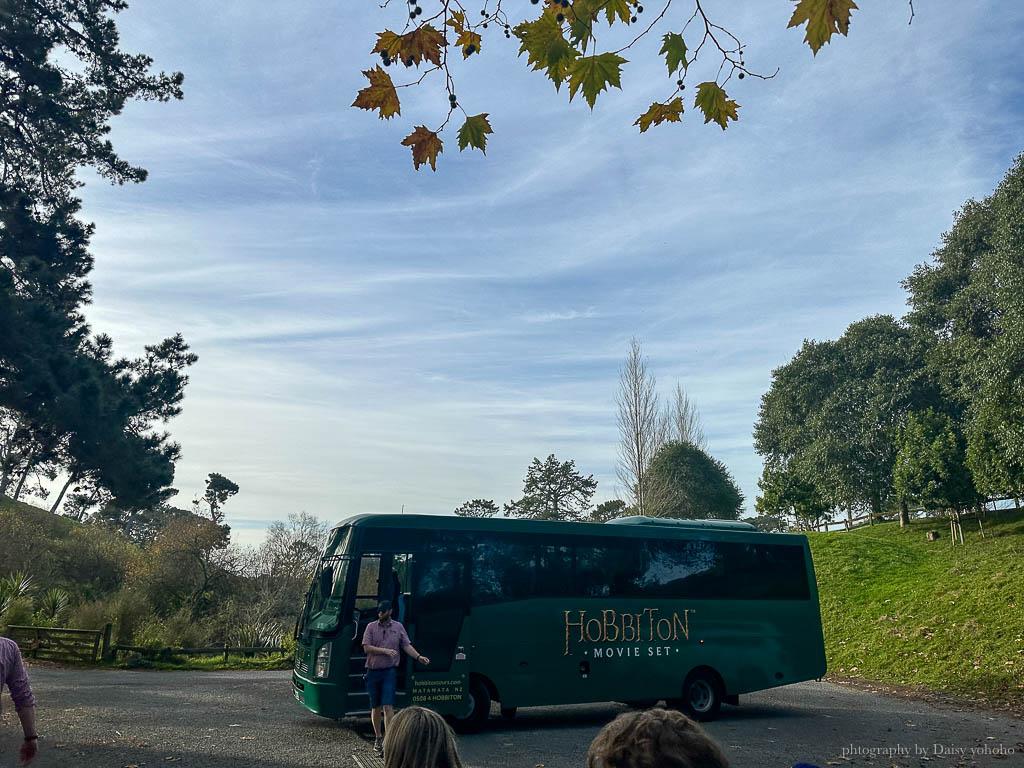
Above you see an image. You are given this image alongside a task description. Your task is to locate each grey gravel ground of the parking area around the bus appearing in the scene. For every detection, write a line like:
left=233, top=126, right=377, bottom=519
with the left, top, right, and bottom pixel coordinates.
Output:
left=0, top=669, right=1024, bottom=768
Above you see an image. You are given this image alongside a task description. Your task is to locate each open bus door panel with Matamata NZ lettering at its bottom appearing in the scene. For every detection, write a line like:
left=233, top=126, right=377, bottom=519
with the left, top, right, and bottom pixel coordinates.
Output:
left=407, top=552, right=470, bottom=716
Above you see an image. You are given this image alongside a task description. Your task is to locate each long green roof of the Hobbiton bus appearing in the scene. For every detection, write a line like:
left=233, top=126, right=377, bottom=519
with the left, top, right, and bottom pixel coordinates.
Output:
left=325, top=513, right=790, bottom=541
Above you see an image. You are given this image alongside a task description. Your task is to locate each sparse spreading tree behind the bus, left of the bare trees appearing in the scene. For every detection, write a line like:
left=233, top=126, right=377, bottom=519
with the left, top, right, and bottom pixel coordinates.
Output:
left=505, top=454, right=597, bottom=520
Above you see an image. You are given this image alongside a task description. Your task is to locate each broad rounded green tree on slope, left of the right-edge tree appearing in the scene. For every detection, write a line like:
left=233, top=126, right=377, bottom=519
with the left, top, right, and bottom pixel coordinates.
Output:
left=754, top=315, right=940, bottom=521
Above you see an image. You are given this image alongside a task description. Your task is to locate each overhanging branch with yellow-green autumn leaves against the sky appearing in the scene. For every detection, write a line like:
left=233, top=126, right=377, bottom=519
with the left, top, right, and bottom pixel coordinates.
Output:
left=352, top=0, right=880, bottom=171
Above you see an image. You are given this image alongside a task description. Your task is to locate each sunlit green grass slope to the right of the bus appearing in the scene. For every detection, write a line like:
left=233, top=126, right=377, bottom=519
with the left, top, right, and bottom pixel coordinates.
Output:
left=808, top=512, right=1024, bottom=705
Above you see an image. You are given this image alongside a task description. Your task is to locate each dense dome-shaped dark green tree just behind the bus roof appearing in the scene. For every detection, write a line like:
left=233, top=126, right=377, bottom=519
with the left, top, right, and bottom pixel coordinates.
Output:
left=647, top=440, right=743, bottom=520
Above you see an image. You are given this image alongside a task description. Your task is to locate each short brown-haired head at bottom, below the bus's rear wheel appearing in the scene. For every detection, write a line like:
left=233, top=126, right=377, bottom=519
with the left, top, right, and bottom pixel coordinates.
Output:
left=587, top=710, right=729, bottom=768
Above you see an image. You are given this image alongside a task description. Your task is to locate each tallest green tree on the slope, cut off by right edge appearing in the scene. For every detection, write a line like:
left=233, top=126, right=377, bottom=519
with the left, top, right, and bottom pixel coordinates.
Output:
left=904, top=155, right=1024, bottom=496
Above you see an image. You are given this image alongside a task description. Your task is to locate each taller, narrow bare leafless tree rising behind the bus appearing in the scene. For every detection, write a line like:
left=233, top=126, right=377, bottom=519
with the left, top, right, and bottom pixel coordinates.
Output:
left=615, top=337, right=664, bottom=515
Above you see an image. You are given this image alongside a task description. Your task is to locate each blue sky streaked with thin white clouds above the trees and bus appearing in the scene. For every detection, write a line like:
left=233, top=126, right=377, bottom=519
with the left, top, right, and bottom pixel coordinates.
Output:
left=64, top=0, right=1024, bottom=545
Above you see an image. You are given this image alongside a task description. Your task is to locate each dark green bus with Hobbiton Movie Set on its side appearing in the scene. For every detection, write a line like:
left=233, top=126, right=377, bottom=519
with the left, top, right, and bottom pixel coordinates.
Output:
left=292, top=514, right=825, bottom=732
